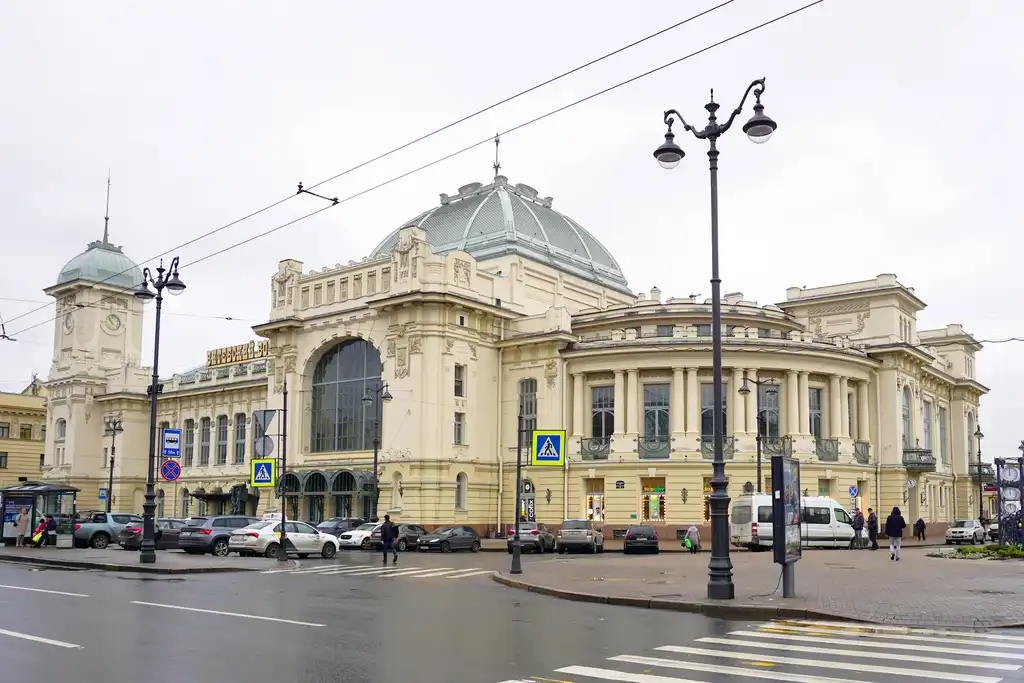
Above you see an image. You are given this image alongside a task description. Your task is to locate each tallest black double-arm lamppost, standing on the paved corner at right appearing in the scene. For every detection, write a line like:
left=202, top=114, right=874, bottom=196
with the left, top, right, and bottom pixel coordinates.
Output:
left=654, top=78, right=776, bottom=600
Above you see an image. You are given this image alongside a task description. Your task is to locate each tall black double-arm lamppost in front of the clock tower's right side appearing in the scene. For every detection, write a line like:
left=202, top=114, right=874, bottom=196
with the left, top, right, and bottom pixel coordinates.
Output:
left=135, top=256, right=185, bottom=564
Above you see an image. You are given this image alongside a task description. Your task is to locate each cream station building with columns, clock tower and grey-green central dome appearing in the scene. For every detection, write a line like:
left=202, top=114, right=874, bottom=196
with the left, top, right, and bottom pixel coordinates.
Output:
left=46, top=176, right=987, bottom=533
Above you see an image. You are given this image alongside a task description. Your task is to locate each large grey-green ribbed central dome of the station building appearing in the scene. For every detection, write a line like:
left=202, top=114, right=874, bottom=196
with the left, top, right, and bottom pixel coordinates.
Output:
left=372, top=175, right=632, bottom=294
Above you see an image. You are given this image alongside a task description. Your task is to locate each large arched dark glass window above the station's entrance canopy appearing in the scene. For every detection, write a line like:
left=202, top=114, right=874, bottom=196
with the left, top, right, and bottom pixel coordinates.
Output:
left=310, top=339, right=383, bottom=453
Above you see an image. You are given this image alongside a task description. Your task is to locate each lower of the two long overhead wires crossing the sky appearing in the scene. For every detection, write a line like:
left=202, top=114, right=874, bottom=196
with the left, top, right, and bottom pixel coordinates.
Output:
left=4, top=0, right=825, bottom=342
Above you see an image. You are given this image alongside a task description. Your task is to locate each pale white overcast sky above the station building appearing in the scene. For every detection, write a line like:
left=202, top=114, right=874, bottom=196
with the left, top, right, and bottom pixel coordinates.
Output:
left=0, top=0, right=1024, bottom=459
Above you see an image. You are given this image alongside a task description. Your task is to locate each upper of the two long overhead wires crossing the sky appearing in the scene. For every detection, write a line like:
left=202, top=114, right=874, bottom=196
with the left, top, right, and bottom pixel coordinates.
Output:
left=7, top=0, right=736, bottom=331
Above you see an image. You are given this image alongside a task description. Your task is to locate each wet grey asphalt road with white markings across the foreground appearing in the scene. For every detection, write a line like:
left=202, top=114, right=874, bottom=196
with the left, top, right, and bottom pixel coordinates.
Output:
left=0, top=553, right=1024, bottom=683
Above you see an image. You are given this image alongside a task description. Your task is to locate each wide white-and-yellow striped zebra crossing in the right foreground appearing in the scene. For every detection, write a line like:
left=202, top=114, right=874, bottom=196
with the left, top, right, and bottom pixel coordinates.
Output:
left=502, top=620, right=1024, bottom=683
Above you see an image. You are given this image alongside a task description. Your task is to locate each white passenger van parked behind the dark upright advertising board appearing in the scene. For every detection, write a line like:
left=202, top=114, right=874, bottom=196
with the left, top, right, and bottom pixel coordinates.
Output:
left=732, top=494, right=853, bottom=550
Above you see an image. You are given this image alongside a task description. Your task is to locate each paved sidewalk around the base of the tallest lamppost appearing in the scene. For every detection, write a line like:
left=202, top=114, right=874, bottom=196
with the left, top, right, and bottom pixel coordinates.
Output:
left=495, top=544, right=1024, bottom=628
